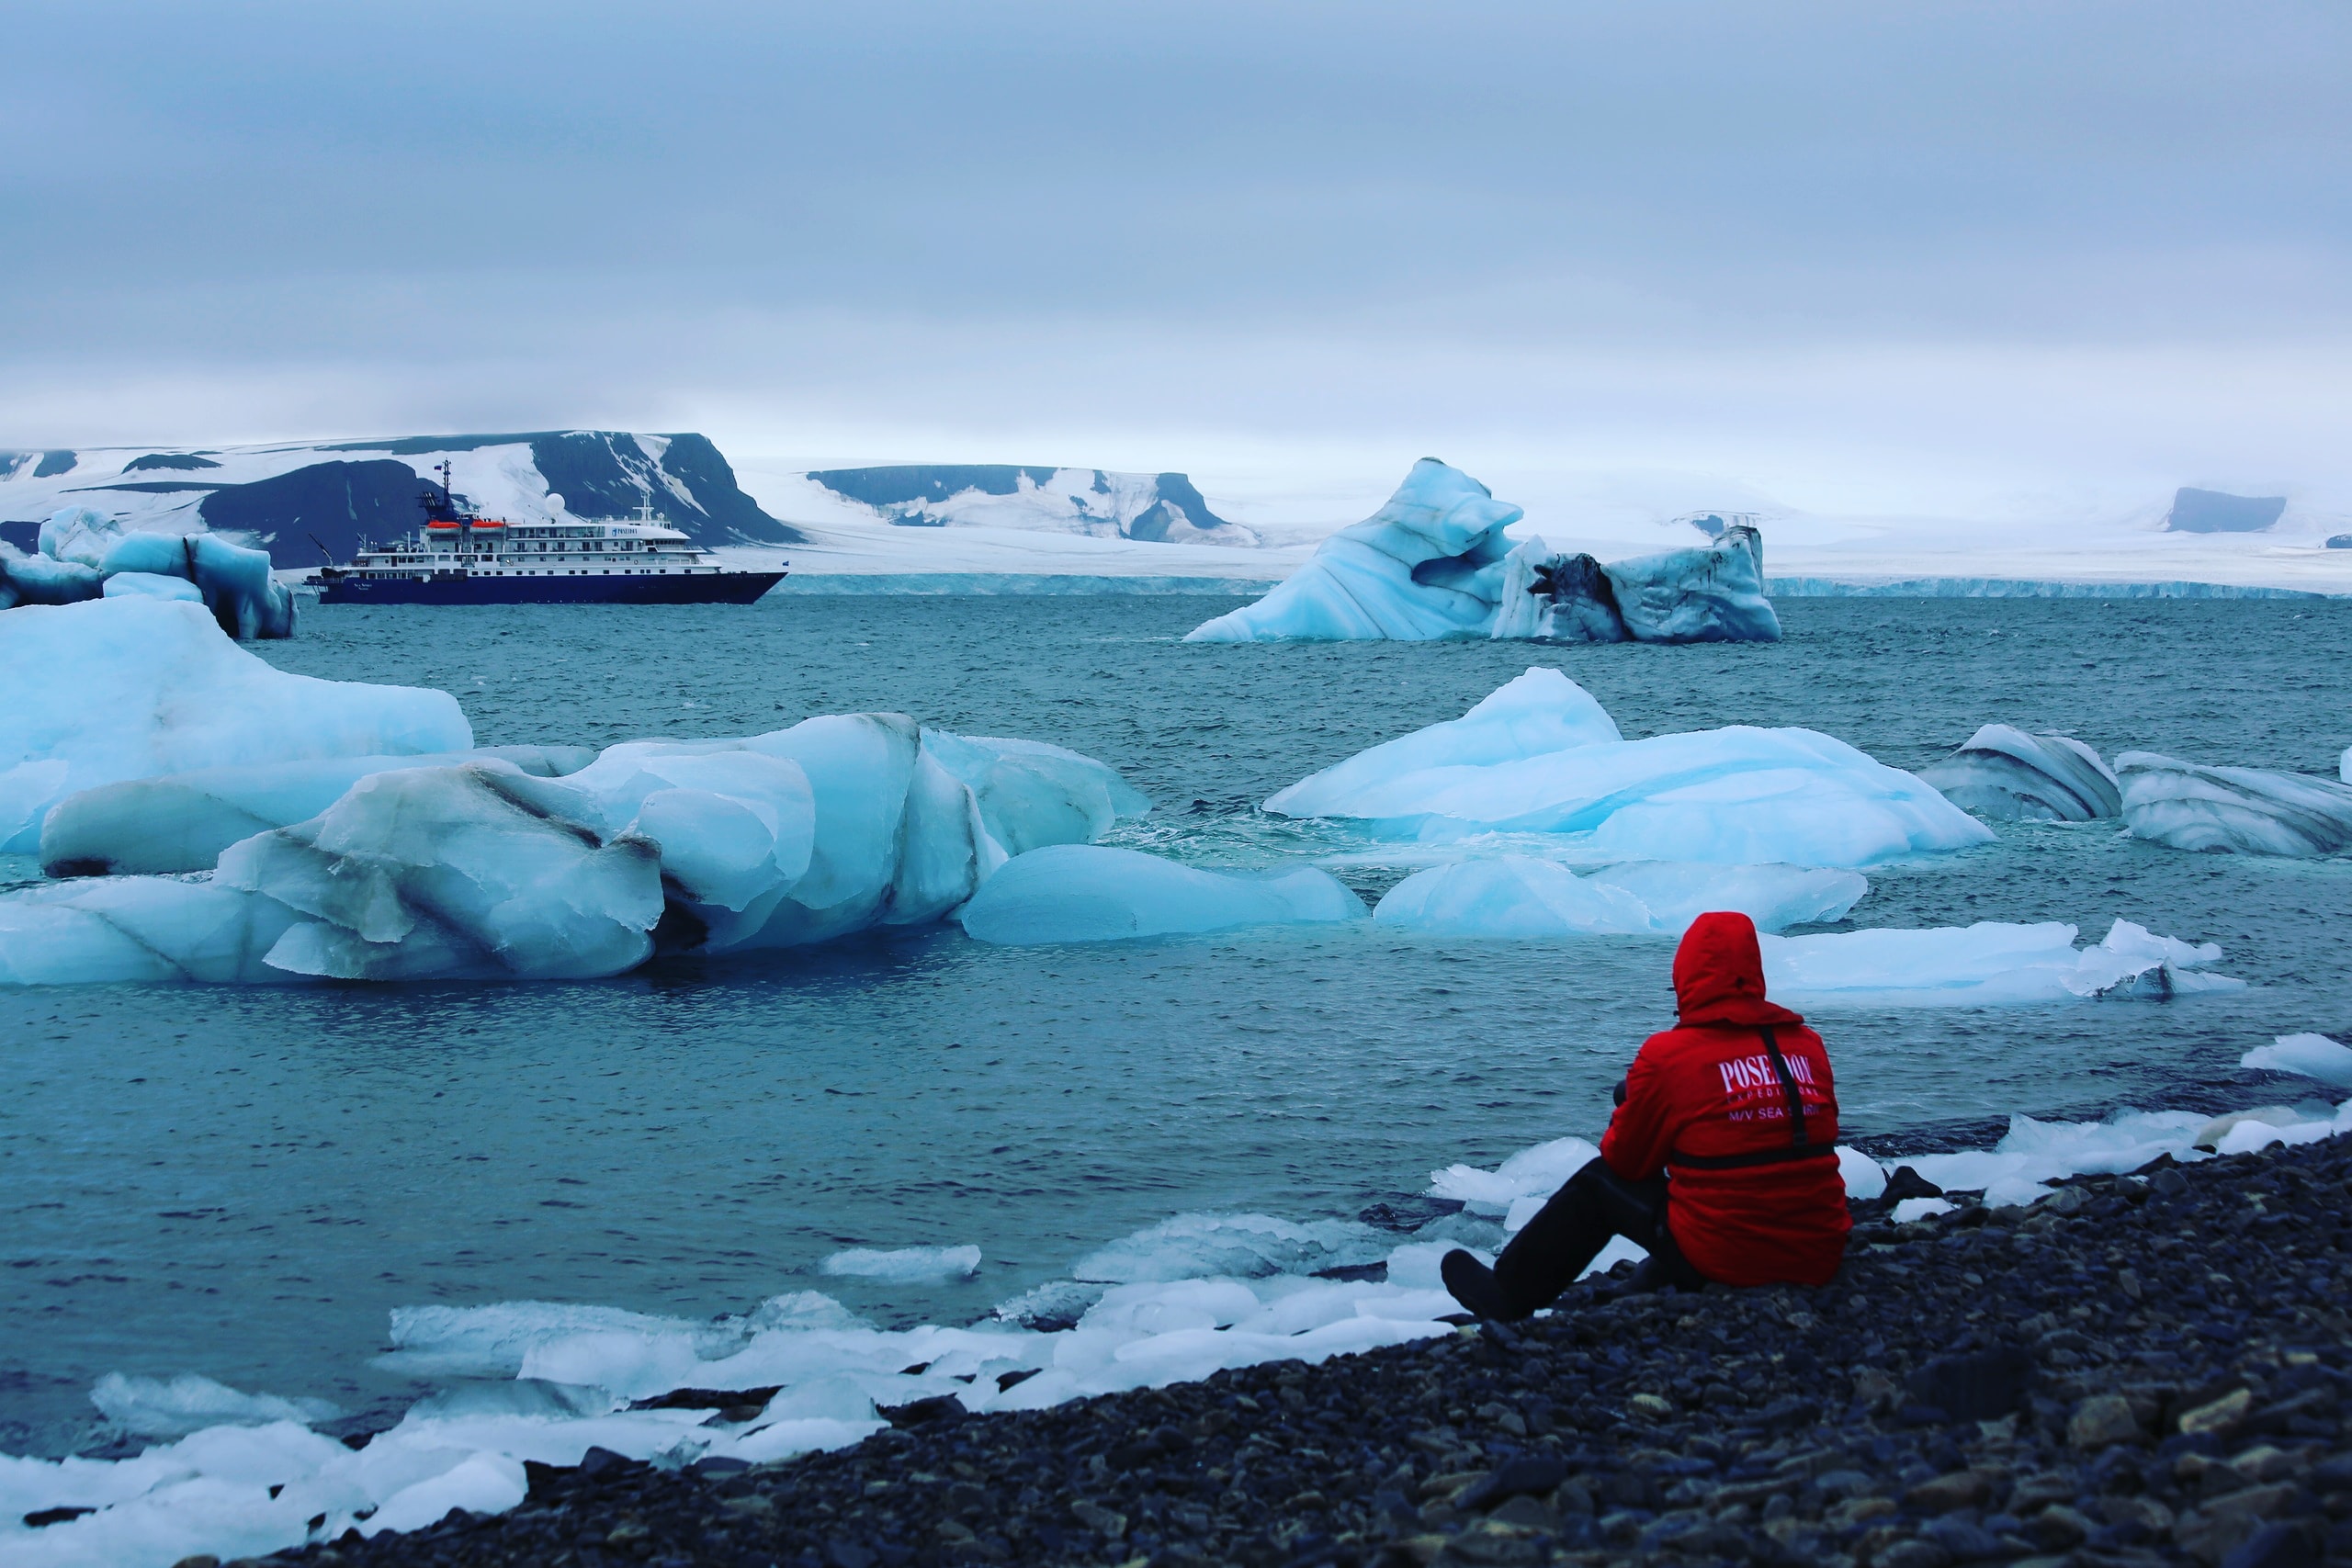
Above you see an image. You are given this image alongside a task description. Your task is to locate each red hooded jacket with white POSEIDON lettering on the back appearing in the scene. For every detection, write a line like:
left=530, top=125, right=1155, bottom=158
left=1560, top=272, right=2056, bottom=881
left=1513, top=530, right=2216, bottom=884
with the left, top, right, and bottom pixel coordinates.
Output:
left=1601, top=915, right=1851, bottom=1286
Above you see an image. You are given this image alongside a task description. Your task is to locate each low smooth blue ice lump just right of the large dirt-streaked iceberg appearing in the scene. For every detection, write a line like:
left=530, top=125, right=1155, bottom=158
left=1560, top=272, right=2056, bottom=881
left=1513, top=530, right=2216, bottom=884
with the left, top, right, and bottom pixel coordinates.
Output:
left=957, top=844, right=1364, bottom=947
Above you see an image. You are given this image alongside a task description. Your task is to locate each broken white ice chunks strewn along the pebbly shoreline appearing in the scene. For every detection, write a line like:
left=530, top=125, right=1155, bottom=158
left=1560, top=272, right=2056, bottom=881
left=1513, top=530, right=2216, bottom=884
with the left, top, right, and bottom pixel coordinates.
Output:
left=0, top=1100, right=2352, bottom=1568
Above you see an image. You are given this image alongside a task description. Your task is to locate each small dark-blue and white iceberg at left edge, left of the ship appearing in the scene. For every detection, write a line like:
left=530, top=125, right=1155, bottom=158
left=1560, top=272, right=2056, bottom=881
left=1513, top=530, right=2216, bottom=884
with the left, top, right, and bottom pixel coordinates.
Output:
left=0, top=505, right=294, bottom=637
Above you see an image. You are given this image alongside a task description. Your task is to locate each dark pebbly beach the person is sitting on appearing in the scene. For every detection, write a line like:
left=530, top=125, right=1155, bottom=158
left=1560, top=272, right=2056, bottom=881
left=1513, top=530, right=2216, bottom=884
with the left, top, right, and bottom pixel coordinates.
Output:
left=202, top=1138, right=2352, bottom=1568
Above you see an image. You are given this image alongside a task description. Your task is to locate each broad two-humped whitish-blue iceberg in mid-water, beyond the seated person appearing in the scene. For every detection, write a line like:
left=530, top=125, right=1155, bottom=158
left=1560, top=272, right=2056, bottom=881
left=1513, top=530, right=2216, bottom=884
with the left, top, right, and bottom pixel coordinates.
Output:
left=1265, top=668, right=1992, bottom=867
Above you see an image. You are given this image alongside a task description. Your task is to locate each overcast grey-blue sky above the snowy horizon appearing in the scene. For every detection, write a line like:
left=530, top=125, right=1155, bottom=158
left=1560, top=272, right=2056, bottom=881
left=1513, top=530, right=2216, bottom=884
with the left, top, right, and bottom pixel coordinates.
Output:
left=0, top=0, right=2352, bottom=513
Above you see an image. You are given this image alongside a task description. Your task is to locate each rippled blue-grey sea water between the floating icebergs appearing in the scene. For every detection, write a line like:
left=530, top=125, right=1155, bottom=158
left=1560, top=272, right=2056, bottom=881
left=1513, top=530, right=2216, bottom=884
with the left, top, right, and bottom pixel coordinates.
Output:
left=0, top=597, right=2352, bottom=1453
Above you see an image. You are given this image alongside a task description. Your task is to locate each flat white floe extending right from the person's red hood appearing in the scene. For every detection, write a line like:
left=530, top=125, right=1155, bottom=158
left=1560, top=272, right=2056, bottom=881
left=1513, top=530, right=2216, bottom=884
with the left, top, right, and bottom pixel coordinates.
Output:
left=1757, top=919, right=2246, bottom=1006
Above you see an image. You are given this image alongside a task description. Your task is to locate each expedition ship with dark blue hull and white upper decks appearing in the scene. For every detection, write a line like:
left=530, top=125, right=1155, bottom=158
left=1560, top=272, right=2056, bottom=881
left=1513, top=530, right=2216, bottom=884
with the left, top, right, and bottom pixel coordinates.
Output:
left=311, top=463, right=786, bottom=604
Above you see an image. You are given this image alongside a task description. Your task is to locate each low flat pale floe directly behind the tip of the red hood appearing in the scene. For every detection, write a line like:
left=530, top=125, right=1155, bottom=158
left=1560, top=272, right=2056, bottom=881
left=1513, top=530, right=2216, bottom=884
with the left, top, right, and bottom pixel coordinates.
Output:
left=1371, top=856, right=1870, bottom=936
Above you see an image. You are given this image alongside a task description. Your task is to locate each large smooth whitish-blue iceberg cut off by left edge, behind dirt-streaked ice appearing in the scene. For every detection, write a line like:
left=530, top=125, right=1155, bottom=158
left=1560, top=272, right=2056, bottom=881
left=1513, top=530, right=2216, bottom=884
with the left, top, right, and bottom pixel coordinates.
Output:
left=0, top=597, right=473, bottom=853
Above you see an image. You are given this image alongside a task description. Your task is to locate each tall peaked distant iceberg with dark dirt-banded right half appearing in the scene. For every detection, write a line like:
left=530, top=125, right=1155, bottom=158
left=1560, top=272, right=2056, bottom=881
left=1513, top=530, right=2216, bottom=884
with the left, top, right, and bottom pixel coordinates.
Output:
left=1185, top=458, right=1781, bottom=642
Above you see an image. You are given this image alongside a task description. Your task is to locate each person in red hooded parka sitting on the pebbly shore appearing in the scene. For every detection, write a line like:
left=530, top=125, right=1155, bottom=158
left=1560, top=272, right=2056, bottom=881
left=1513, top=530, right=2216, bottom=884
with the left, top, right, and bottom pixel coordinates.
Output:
left=1442, top=912, right=1851, bottom=1321
